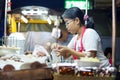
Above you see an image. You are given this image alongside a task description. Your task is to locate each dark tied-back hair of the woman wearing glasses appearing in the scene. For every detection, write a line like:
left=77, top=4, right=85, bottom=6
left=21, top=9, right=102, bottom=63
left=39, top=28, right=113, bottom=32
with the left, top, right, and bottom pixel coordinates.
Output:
left=62, top=7, right=94, bottom=28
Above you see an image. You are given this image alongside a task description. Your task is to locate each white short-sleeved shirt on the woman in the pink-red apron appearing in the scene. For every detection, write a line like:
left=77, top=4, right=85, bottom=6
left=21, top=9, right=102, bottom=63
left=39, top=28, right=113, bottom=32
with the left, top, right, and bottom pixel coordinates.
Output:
left=68, top=28, right=110, bottom=67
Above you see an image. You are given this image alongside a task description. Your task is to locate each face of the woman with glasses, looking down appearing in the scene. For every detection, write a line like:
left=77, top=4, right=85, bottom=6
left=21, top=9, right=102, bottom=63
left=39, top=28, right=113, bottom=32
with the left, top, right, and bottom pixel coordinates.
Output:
left=64, top=18, right=79, bottom=34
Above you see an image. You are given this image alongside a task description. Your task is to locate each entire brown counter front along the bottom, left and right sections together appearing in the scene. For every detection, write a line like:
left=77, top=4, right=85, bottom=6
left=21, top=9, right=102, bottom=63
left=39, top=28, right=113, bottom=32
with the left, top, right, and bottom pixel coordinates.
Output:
left=0, top=68, right=115, bottom=80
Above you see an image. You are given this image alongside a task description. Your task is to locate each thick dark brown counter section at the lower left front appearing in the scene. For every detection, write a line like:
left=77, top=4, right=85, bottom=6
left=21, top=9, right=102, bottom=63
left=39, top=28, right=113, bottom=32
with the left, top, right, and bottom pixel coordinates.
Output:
left=0, top=68, right=53, bottom=80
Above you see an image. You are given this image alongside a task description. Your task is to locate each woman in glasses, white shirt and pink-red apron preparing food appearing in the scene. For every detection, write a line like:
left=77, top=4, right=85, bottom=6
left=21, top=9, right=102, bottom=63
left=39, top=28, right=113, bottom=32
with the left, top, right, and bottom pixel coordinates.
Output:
left=52, top=7, right=110, bottom=67
